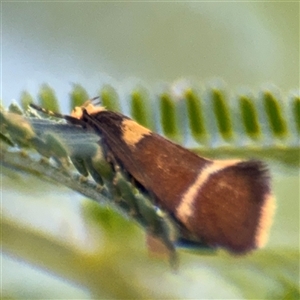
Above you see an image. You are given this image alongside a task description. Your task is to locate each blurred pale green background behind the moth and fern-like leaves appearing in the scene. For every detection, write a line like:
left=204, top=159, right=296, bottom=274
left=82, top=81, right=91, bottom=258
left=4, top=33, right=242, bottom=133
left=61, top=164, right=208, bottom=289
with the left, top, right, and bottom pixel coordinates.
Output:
left=1, top=1, right=299, bottom=299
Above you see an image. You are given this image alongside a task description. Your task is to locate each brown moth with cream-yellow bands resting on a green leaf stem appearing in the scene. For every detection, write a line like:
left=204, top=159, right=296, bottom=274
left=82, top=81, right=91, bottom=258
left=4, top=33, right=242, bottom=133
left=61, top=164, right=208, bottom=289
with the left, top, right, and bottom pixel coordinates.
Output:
left=31, top=99, right=274, bottom=254
